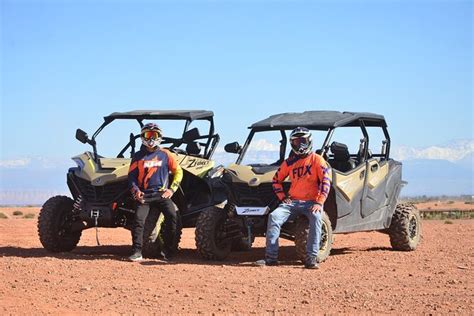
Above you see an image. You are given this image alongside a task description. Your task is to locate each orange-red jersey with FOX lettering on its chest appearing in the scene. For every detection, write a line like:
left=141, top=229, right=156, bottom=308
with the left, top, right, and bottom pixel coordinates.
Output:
left=273, top=153, right=331, bottom=205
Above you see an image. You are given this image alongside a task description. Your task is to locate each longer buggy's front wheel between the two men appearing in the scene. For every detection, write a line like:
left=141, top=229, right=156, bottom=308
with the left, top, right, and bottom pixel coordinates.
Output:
left=196, top=207, right=232, bottom=260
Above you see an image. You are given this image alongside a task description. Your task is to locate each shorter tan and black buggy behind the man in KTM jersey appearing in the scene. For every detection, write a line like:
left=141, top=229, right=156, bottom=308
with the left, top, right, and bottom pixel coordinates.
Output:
left=38, top=110, right=226, bottom=257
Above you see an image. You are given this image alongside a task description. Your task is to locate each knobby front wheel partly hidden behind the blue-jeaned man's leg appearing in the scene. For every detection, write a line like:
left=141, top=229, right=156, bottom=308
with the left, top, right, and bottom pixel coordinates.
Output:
left=295, top=211, right=333, bottom=263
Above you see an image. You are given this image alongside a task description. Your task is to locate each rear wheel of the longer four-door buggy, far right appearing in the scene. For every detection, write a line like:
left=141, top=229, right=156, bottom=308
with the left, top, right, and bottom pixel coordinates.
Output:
left=388, top=204, right=421, bottom=251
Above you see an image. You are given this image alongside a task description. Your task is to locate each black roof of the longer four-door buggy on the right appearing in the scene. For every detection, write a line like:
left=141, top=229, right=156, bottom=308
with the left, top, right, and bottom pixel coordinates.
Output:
left=249, top=111, right=387, bottom=131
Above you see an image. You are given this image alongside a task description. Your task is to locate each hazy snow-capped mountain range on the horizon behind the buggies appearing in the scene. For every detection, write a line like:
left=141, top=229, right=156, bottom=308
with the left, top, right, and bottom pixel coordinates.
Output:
left=0, top=139, right=474, bottom=205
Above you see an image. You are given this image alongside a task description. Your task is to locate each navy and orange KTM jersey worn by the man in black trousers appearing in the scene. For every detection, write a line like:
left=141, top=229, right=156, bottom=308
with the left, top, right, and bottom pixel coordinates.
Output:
left=128, top=148, right=183, bottom=193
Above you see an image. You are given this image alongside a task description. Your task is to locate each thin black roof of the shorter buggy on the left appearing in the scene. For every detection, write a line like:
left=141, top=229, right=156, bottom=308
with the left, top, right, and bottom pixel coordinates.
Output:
left=104, top=110, right=214, bottom=121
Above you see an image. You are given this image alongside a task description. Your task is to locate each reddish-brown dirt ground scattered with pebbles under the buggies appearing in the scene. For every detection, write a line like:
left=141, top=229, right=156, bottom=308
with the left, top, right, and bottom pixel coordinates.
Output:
left=0, top=208, right=474, bottom=315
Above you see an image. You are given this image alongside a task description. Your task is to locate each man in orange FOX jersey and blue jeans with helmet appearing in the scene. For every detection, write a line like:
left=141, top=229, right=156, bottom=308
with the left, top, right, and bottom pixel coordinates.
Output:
left=257, top=127, right=331, bottom=269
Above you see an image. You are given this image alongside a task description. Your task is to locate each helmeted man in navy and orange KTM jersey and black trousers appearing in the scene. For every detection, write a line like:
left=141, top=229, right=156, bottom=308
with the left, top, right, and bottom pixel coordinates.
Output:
left=128, top=123, right=183, bottom=261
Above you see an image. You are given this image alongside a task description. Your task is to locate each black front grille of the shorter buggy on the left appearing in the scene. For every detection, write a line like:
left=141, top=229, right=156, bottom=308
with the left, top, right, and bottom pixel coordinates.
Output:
left=71, top=175, right=128, bottom=203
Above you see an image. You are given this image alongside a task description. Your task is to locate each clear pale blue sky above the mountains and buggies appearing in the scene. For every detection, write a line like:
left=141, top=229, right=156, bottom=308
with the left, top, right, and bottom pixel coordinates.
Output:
left=0, top=0, right=474, bottom=160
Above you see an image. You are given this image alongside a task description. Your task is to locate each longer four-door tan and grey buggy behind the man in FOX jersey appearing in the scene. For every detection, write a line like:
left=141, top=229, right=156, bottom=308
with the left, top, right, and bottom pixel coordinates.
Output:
left=196, top=111, right=421, bottom=262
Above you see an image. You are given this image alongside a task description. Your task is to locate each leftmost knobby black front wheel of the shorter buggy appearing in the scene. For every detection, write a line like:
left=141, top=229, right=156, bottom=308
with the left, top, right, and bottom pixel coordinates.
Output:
left=38, top=195, right=82, bottom=252
